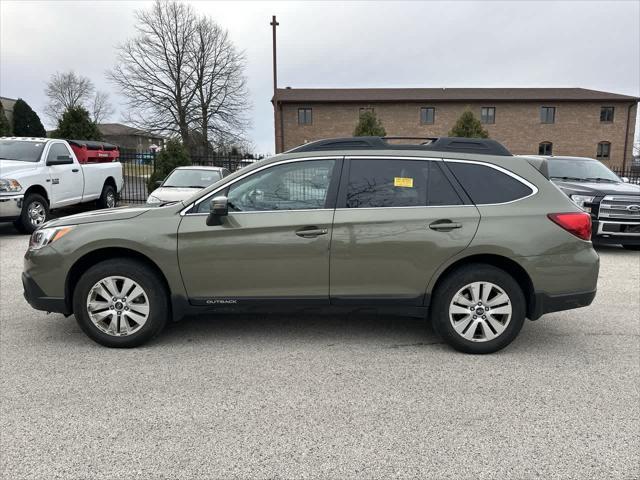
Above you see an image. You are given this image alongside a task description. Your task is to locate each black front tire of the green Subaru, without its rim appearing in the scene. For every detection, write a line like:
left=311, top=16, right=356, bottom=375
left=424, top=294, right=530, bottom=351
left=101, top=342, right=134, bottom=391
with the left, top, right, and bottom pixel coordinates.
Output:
left=73, top=258, right=170, bottom=348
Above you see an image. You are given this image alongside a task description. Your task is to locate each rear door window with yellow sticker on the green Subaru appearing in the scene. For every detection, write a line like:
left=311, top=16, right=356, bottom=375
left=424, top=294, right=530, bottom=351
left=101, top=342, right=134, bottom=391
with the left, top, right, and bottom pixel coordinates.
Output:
left=345, top=158, right=462, bottom=208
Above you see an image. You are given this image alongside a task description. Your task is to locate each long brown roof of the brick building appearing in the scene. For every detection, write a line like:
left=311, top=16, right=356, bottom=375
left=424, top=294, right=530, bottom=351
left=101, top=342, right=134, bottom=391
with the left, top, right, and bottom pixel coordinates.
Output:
left=275, top=88, right=640, bottom=103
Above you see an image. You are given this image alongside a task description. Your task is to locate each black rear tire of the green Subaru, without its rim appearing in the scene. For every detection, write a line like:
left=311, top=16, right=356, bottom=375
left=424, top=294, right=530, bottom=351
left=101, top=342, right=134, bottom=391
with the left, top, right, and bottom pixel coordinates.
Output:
left=431, top=264, right=526, bottom=354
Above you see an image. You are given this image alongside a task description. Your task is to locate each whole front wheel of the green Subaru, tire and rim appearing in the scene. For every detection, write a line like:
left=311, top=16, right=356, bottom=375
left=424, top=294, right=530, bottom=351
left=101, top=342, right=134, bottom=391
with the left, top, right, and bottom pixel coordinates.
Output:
left=73, top=259, right=169, bottom=348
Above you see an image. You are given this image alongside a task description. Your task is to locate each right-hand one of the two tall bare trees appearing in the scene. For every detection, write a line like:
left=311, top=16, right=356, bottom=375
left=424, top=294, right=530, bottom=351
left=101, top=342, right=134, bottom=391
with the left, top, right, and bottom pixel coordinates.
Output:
left=192, top=17, right=248, bottom=154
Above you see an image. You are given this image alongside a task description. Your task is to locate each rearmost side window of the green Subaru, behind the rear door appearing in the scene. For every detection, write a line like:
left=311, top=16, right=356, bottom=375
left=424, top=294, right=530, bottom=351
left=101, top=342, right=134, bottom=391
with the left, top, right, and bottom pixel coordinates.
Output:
left=446, top=162, right=533, bottom=205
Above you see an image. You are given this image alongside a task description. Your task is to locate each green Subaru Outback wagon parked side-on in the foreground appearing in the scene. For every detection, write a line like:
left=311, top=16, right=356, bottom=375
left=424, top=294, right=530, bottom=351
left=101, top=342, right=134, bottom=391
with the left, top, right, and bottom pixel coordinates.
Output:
left=22, top=137, right=599, bottom=353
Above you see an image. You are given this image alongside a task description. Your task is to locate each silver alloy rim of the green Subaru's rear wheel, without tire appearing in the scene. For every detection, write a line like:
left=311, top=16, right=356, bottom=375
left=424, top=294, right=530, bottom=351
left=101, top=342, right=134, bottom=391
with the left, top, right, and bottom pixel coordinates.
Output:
left=449, top=282, right=512, bottom=342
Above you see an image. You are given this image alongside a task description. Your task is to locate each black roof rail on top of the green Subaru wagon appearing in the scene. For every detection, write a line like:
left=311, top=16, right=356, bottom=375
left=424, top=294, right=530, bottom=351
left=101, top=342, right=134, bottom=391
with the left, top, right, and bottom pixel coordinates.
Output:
left=287, top=137, right=512, bottom=157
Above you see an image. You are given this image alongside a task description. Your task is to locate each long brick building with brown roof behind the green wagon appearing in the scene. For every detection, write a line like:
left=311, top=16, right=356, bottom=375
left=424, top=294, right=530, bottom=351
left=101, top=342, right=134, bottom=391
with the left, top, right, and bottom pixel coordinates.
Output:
left=272, top=88, right=640, bottom=167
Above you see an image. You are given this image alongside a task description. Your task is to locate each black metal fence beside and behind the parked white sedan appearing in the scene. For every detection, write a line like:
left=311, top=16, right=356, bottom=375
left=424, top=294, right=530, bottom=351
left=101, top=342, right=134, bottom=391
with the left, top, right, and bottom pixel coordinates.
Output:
left=120, top=150, right=262, bottom=204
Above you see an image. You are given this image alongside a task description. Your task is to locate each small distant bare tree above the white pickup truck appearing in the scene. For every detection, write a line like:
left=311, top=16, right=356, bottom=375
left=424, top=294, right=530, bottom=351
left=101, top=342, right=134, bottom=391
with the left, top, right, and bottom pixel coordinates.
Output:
left=45, top=71, right=94, bottom=121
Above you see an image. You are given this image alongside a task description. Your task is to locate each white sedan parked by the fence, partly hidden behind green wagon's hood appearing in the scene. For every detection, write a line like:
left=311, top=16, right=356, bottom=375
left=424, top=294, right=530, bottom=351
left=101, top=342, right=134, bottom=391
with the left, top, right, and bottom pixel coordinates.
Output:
left=147, top=166, right=230, bottom=205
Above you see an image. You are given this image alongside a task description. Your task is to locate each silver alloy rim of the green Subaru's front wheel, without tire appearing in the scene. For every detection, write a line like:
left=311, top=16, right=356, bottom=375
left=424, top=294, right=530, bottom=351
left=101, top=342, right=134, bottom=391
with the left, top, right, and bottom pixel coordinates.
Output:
left=87, top=276, right=149, bottom=337
